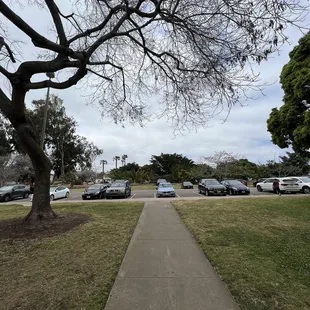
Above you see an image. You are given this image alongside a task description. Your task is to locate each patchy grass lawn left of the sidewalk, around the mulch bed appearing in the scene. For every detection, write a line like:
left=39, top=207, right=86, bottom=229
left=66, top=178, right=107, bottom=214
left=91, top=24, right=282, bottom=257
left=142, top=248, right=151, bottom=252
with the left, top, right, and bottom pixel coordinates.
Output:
left=0, top=202, right=143, bottom=309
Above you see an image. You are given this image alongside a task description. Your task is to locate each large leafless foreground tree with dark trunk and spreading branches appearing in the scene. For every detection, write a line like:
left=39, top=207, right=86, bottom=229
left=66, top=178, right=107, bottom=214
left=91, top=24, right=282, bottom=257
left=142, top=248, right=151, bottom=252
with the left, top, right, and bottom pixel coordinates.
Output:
left=0, top=0, right=305, bottom=221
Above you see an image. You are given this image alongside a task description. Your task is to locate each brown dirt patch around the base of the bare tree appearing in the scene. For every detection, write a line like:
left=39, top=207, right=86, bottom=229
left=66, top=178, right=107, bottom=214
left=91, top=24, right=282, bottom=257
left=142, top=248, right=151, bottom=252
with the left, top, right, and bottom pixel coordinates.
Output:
left=0, top=213, right=90, bottom=241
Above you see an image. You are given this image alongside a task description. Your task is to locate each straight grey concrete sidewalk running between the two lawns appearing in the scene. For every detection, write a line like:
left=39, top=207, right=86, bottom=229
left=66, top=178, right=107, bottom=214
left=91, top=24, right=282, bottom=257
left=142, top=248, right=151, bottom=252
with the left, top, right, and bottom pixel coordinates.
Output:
left=105, top=201, right=239, bottom=310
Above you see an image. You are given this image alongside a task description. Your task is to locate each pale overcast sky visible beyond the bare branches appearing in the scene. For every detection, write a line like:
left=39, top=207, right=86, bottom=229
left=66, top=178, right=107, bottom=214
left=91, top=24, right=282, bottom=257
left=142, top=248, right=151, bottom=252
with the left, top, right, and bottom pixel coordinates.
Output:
left=0, top=1, right=302, bottom=170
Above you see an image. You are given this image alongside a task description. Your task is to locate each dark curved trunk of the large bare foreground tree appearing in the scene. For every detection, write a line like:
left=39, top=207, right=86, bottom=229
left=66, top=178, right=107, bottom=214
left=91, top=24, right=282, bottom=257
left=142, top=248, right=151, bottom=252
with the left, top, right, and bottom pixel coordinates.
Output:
left=0, top=88, right=56, bottom=222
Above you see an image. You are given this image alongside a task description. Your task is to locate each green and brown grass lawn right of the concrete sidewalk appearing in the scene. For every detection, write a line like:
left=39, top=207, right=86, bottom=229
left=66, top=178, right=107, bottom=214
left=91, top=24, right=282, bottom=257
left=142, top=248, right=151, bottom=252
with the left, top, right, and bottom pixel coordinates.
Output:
left=173, top=197, right=310, bottom=310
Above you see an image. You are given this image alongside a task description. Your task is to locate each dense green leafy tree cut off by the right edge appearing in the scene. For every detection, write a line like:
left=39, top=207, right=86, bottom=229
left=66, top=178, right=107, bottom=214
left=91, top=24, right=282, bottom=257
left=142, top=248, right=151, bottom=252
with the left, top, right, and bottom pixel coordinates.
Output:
left=267, top=32, right=310, bottom=153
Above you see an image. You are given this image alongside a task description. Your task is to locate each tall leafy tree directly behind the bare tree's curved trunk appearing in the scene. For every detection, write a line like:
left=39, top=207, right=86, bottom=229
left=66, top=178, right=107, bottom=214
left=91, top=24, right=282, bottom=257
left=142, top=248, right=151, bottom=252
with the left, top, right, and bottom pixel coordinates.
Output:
left=7, top=95, right=102, bottom=178
